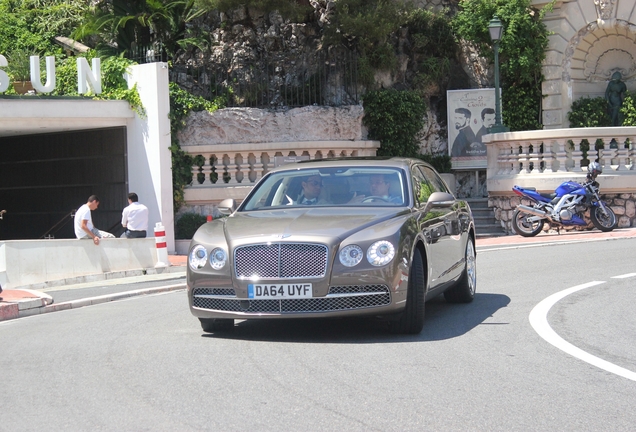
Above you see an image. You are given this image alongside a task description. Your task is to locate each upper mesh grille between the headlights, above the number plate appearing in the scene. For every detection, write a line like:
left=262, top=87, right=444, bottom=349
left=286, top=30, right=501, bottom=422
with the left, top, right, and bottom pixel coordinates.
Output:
left=234, top=243, right=327, bottom=279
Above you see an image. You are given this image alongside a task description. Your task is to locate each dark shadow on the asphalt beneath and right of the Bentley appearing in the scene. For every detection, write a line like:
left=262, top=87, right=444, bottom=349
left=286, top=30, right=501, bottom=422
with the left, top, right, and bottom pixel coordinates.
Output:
left=202, top=293, right=510, bottom=344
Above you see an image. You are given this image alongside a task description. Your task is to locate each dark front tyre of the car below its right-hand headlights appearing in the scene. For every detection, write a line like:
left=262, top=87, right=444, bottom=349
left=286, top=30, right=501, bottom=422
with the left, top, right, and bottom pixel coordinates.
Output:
left=389, top=249, right=426, bottom=334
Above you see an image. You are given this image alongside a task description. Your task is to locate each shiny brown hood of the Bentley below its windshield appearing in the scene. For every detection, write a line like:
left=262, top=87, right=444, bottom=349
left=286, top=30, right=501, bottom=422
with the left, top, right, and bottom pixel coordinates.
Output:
left=225, top=207, right=408, bottom=244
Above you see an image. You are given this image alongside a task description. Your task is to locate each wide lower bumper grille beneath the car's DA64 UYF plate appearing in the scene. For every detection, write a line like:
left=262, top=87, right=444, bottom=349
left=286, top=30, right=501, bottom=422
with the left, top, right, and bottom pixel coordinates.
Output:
left=193, top=285, right=391, bottom=314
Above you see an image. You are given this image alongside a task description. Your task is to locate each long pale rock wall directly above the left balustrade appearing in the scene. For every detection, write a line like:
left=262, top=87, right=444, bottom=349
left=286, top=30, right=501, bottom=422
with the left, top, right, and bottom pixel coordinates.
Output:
left=178, top=105, right=367, bottom=146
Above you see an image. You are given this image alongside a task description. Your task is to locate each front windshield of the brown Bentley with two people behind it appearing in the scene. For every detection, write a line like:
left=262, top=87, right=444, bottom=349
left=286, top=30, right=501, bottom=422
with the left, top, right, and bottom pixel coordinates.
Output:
left=239, top=166, right=408, bottom=211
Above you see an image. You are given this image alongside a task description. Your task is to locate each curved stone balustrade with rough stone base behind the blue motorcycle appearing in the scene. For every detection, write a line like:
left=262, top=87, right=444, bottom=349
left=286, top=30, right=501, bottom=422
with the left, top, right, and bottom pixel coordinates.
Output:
left=483, top=127, right=636, bottom=232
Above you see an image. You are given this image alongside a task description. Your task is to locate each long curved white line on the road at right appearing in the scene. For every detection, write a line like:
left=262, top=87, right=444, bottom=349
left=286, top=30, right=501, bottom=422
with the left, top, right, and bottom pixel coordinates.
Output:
left=529, top=281, right=636, bottom=381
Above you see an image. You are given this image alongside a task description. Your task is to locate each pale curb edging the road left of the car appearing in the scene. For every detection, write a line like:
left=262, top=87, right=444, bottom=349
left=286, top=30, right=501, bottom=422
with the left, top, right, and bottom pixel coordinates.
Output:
left=0, top=282, right=186, bottom=321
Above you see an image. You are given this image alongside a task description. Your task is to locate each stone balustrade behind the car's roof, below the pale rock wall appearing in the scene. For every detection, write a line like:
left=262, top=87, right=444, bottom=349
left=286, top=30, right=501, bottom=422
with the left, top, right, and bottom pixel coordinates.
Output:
left=181, top=140, right=380, bottom=205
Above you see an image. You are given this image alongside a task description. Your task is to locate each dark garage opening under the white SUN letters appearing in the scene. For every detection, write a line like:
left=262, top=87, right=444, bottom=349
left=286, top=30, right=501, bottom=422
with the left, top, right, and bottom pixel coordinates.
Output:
left=0, top=127, right=128, bottom=240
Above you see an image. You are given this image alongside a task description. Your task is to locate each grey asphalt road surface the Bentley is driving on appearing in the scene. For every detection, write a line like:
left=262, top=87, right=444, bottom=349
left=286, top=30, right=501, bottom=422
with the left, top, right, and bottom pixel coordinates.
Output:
left=0, top=239, right=636, bottom=431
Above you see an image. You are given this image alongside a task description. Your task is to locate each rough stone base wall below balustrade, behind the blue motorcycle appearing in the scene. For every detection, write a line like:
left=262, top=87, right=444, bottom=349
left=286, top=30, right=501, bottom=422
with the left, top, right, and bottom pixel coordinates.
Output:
left=488, top=193, right=636, bottom=234
